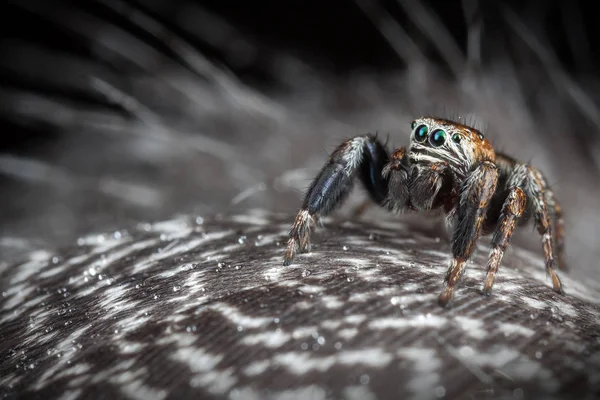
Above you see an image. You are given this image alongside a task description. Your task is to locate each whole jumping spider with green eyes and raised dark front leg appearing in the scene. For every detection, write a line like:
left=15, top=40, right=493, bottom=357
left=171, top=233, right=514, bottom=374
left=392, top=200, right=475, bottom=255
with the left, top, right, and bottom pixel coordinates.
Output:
left=284, top=117, right=565, bottom=306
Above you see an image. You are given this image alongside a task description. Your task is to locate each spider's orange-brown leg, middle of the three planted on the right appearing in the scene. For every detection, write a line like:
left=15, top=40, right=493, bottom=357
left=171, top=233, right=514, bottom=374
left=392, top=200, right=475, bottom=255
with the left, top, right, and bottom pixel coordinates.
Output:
left=483, top=187, right=527, bottom=295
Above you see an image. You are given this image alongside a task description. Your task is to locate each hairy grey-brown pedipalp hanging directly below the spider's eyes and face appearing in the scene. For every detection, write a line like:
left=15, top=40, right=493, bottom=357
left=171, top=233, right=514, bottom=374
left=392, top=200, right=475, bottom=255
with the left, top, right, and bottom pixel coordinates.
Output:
left=409, top=161, right=448, bottom=210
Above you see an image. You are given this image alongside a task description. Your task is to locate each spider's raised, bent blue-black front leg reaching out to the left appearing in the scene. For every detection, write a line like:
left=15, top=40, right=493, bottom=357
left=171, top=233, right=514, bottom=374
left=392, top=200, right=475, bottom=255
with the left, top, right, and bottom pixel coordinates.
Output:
left=283, top=134, right=389, bottom=265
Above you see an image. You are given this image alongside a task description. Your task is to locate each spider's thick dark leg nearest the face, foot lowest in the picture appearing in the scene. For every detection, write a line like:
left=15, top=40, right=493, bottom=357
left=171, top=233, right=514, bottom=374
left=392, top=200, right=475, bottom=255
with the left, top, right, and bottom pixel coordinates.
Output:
left=438, top=161, right=498, bottom=306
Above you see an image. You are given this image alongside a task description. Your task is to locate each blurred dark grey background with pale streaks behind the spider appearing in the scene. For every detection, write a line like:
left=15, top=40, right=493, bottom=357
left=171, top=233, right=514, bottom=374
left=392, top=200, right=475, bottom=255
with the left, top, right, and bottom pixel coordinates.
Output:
left=0, top=0, right=600, bottom=282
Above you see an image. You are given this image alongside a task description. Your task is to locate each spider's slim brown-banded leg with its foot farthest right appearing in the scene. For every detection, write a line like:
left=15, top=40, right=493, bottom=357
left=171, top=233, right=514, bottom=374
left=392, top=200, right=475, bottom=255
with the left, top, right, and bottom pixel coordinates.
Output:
left=523, top=165, right=563, bottom=294
